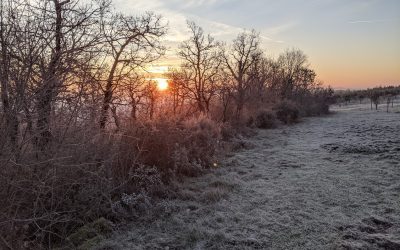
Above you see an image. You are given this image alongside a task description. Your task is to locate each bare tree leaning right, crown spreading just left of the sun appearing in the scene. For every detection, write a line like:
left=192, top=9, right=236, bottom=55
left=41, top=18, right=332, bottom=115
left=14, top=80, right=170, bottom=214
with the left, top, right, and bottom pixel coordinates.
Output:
left=100, top=13, right=166, bottom=129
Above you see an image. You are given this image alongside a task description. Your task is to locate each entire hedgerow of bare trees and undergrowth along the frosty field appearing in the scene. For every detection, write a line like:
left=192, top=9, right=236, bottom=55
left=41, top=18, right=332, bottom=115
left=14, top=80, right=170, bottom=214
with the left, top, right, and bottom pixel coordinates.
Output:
left=0, top=0, right=333, bottom=246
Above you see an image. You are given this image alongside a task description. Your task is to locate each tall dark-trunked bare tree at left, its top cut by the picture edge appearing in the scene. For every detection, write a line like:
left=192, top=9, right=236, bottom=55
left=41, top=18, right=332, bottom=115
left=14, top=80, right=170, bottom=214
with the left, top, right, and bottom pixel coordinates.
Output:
left=31, top=0, right=108, bottom=150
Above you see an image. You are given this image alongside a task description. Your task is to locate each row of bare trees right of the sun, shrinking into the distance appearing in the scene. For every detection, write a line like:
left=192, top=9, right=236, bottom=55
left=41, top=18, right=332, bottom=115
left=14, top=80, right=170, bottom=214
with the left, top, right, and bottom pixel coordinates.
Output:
left=168, top=22, right=333, bottom=121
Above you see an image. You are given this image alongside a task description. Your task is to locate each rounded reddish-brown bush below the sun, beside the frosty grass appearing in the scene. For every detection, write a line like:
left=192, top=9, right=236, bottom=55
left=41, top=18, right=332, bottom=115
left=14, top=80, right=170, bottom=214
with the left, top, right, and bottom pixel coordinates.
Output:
left=114, top=116, right=221, bottom=182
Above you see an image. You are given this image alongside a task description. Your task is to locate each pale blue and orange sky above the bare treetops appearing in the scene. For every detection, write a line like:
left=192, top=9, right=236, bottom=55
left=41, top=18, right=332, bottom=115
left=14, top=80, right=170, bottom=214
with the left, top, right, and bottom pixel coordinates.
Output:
left=113, top=0, right=400, bottom=89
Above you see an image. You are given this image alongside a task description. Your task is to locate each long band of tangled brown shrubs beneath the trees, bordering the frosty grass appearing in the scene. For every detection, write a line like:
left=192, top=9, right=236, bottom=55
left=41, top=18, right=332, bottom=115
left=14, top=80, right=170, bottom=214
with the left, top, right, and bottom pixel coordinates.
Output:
left=0, top=116, right=221, bottom=249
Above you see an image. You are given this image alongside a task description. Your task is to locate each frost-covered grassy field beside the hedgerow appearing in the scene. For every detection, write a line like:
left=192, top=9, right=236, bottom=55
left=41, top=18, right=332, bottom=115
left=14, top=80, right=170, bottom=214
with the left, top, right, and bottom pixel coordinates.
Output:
left=98, top=102, right=400, bottom=249
